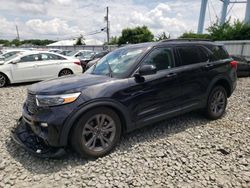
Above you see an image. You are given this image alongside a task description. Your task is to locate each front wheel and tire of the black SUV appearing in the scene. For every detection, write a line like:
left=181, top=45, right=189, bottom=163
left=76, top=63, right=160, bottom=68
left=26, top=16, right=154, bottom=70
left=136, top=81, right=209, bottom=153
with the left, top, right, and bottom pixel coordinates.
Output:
left=71, top=107, right=121, bottom=158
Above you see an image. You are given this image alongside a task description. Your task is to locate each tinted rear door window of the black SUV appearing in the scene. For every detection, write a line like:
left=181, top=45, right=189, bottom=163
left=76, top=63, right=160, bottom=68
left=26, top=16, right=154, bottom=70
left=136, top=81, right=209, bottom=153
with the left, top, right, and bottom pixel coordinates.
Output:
left=177, top=46, right=209, bottom=65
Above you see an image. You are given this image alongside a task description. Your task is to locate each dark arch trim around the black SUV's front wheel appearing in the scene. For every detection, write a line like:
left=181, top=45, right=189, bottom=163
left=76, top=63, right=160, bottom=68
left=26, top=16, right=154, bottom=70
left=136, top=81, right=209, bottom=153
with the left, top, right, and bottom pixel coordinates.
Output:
left=60, top=100, right=130, bottom=146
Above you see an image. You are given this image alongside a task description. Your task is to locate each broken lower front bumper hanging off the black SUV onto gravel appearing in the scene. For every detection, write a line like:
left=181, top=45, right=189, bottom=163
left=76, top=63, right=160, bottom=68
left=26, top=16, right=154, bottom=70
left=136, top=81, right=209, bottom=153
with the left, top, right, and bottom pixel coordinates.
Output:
left=11, top=118, right=66, bottom=158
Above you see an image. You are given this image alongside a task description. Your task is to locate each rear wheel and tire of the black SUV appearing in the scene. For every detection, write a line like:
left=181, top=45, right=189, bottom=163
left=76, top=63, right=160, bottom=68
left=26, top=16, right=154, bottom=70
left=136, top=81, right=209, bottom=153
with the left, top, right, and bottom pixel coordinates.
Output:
left=205, top=86, right=227, bottom=120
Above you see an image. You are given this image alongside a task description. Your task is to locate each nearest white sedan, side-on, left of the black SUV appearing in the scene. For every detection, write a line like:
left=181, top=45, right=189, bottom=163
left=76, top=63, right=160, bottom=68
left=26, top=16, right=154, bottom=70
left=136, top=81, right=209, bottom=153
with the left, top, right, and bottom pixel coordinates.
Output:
left=0, top=51, right=82, bottom=87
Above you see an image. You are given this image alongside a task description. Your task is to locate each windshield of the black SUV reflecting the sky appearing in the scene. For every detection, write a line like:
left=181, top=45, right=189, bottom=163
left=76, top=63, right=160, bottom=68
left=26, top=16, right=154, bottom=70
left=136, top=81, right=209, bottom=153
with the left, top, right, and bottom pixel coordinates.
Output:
left=86, top=47, right=145, bottom=77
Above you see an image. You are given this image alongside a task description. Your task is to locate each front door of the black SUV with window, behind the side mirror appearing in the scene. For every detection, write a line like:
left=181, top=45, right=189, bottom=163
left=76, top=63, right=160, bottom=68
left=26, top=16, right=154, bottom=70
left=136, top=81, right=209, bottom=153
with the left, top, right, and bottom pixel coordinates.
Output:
left=125, top=47, right=181, bottom=126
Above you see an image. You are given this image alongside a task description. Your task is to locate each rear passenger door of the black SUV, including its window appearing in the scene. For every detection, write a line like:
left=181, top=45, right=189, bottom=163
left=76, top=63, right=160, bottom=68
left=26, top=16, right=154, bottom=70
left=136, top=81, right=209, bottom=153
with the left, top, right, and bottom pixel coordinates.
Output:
left=176, top=45, right=213, bottom=110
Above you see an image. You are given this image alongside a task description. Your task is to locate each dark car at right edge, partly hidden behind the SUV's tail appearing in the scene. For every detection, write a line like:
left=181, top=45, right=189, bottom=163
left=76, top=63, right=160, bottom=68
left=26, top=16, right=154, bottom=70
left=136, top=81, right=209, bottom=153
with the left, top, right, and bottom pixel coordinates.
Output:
left=231, top=55, right=250, bottom=77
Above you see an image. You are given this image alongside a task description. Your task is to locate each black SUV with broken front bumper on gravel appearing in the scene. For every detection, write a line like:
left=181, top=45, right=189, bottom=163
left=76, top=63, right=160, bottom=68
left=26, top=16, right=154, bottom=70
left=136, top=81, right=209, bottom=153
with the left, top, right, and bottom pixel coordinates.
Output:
left=12, top=39, right=237, bottom=158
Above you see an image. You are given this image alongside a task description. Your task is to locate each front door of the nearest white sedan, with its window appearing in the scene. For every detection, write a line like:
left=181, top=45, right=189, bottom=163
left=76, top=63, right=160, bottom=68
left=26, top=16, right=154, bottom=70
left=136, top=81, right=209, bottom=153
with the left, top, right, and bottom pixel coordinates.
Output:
left=11, top=54, right=40, bottom=82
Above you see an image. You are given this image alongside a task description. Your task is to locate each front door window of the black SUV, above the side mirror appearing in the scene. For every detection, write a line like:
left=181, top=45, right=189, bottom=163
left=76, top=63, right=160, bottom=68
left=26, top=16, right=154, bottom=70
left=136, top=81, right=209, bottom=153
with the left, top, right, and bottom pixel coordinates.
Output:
left=143, top=48, right=173, bottom=70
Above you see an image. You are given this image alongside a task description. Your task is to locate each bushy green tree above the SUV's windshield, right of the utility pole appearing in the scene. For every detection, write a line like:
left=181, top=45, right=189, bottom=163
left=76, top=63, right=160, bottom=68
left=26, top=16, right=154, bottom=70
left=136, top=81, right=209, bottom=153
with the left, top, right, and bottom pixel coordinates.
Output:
left=118, top=26, right=154, bottom=45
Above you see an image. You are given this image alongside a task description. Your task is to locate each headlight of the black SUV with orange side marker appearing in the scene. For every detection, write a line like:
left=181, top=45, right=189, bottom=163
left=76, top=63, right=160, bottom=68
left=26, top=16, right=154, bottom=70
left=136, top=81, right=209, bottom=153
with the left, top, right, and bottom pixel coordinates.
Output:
left=36, top=92, right=81, bottom=106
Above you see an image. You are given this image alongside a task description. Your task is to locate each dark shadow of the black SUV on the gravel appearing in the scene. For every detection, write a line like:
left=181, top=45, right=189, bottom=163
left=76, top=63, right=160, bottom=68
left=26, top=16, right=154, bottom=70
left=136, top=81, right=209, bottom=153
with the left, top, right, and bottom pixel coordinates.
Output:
left=6, top=112, right=217, bottom=174
